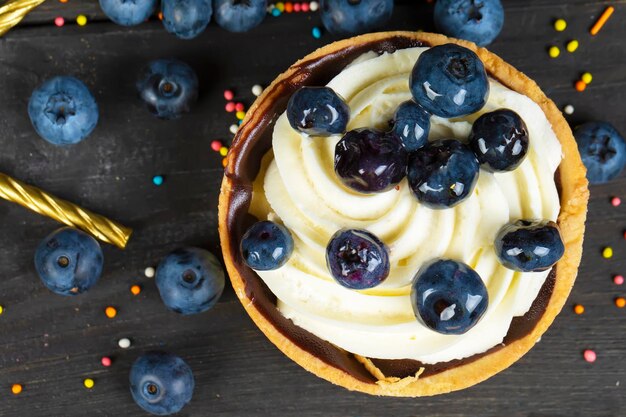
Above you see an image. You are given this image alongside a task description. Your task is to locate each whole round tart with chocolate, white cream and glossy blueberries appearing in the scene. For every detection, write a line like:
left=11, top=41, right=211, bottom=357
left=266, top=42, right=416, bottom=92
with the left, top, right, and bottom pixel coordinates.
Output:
left=219, top=32, right=588, bottom=397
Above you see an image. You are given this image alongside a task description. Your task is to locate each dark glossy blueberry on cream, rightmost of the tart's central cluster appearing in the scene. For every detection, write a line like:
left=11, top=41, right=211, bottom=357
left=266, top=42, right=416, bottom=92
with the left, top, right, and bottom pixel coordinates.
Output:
left=469, top=109, right=528, bottom=172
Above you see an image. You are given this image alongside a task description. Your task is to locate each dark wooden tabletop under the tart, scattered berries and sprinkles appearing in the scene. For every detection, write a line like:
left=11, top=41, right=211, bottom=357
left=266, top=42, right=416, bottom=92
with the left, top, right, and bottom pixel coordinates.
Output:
left=0, top=0, right=626, bottom=417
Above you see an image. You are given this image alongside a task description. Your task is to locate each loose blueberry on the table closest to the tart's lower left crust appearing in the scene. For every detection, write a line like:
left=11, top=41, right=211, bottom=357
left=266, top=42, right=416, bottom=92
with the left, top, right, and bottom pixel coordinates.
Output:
left=155, top=248, right=225, bottom=314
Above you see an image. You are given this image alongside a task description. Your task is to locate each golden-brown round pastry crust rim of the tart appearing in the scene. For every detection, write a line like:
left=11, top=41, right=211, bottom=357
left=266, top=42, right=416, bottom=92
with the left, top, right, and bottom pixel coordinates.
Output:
left=219, top=32, right=589, bottom=397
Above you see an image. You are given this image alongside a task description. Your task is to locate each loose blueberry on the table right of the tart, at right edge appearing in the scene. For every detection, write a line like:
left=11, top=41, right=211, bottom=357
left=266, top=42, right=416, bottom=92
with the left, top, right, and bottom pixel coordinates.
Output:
left=574, top=122, right=626, bottom=184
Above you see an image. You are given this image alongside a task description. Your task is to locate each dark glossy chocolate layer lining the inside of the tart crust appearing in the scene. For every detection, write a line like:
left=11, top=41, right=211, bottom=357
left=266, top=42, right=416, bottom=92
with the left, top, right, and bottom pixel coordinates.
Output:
left=226, top=36, right=556, bottom=383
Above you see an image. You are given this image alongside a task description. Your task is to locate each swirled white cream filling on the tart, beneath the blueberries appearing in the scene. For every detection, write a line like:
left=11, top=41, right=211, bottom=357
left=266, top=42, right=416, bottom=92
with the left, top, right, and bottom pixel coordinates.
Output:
left=251, top=48, right=561, bottom=363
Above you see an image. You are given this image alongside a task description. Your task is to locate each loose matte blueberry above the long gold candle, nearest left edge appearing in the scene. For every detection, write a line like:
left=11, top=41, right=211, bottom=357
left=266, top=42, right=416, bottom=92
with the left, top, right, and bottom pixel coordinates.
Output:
left=28, top=77, right=99, bottom=146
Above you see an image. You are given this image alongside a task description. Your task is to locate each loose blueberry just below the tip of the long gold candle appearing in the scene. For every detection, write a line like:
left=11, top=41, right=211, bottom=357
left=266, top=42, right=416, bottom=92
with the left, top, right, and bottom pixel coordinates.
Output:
left=35, top=227, right=104, bottom=295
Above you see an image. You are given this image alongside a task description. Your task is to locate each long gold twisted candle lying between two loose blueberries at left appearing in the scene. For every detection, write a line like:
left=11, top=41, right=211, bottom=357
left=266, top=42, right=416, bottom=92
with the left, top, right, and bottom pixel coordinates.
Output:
left=0, top=172, right=132, bottom=249
